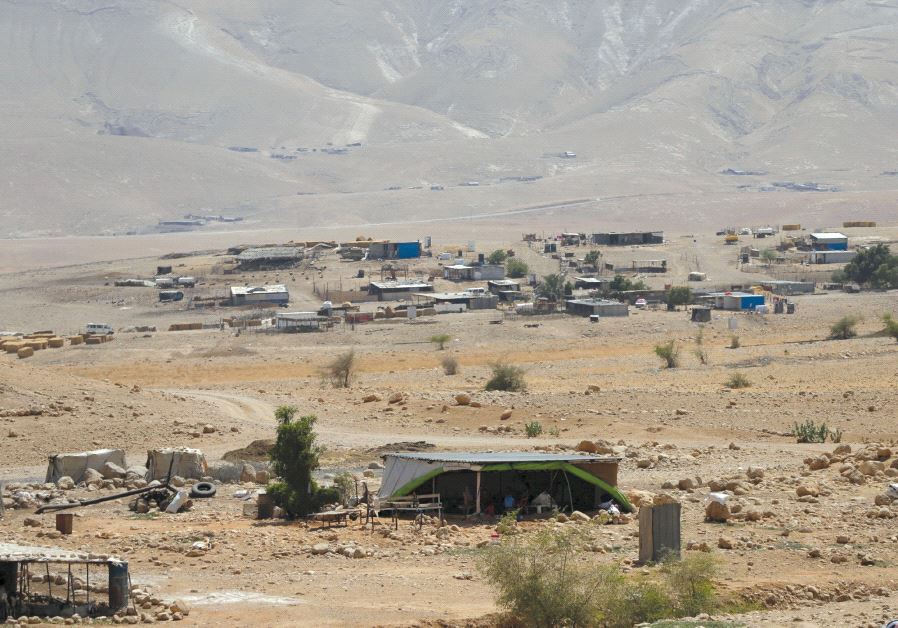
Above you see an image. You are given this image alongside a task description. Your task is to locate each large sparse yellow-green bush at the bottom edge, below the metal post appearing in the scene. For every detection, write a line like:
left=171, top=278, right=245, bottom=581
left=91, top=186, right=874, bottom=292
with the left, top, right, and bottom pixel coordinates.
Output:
left=479, top=529, right=721, bottom=628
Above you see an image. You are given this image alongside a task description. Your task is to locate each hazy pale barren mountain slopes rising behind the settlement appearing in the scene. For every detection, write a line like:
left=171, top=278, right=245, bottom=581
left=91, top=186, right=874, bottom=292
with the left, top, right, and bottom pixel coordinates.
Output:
left=0, top=0, right=898, bottom=237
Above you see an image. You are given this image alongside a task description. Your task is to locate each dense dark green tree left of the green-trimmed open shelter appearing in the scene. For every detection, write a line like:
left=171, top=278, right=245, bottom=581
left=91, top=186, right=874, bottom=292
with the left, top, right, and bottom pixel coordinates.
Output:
left=268, top=406, right=340, bottom=517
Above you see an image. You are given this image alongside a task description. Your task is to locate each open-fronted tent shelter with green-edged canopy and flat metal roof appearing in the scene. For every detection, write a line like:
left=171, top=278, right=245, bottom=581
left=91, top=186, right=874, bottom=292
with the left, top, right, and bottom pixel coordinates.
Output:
left=378, top=452, right=632, bottom=514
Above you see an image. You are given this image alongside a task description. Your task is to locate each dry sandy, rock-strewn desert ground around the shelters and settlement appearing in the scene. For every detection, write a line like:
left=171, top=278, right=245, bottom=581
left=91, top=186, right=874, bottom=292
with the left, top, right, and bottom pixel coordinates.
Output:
left=0, top=221, right=898, bottom=626
